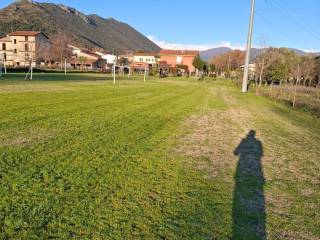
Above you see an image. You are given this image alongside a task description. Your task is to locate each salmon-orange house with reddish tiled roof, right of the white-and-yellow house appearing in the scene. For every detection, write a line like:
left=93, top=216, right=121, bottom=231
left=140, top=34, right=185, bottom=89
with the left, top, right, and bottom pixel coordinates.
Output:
left=159, top=49, right=199, bottom=73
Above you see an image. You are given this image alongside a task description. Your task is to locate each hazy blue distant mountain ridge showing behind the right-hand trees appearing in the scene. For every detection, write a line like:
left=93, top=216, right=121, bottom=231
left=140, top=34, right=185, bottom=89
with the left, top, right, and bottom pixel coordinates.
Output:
left=200, top=47, right=320, bottom=61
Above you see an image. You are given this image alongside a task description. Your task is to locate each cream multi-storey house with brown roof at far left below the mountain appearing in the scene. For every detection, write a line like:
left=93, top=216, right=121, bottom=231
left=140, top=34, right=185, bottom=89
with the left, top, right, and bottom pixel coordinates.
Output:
left=0, top=31, right=50, bottom=67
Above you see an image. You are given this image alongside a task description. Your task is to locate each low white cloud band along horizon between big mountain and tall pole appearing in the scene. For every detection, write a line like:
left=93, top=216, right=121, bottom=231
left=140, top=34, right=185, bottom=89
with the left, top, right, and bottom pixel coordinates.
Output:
left=148, top=35, right=245, bottom=51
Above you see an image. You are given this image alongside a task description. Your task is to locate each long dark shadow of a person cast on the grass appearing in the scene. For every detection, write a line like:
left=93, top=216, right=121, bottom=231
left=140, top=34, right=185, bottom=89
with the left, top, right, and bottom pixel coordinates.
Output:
left=232, top=130, right=267, bottom=240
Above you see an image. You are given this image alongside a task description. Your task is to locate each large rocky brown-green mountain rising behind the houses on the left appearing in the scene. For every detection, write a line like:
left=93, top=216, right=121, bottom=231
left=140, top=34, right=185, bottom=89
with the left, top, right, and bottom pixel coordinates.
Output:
left=0, top=0, right=160, bottom=53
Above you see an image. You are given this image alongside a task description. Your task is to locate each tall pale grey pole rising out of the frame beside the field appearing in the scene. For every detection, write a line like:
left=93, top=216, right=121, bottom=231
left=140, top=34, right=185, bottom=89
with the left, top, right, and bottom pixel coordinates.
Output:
left=242, top=0, right=255, bottom=92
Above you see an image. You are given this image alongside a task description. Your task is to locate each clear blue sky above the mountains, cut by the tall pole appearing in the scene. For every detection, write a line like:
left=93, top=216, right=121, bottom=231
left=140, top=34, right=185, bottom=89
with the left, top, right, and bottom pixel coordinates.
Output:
left=0, top=0, right=320, bottom=51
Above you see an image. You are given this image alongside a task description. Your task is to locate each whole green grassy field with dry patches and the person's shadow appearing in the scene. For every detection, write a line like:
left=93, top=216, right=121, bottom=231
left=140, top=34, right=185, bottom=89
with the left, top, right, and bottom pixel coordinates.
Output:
left=0, top=74, right=320, bottom=239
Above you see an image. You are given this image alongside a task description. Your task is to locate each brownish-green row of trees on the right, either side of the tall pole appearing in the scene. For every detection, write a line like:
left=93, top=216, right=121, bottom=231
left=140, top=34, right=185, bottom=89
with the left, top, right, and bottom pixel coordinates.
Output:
left=207, top=48, right=320, bottom=88
